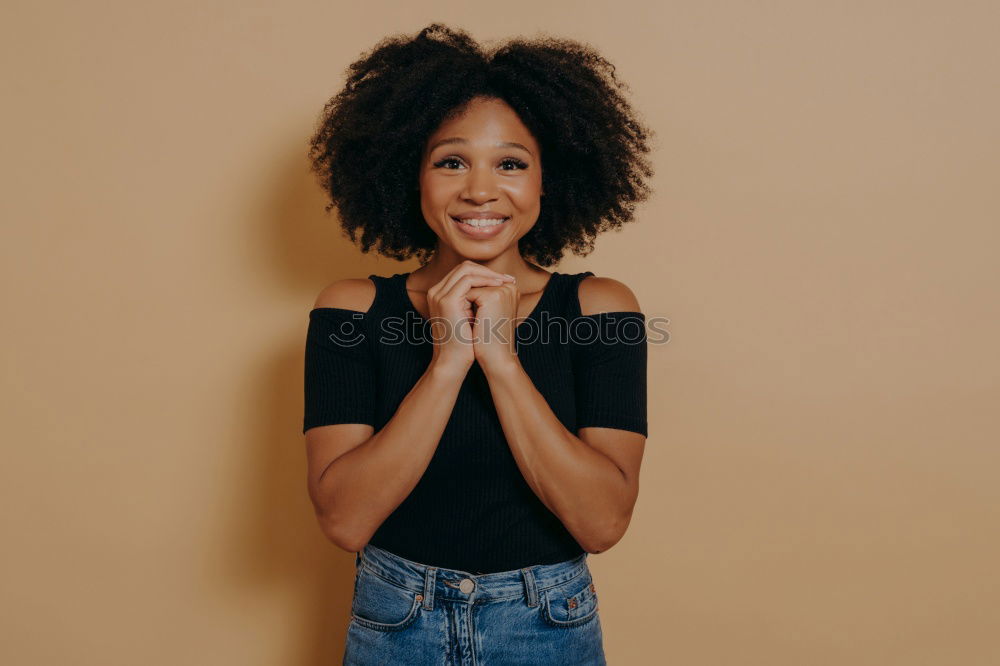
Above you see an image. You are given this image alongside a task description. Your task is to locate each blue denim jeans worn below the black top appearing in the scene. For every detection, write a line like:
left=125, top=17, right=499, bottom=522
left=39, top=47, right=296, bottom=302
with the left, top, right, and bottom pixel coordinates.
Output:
left=344, top=544, right=607, bottom=666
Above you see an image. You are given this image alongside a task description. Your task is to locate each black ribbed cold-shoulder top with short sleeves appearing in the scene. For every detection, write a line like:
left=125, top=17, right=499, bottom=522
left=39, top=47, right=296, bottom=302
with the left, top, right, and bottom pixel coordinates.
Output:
left=302, top=271, right=647, bottom=574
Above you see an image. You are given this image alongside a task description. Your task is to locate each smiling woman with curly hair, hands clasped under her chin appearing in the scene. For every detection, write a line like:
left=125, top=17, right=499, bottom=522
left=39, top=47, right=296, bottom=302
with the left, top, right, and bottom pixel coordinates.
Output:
left=303, top=24, right=651, bottom=666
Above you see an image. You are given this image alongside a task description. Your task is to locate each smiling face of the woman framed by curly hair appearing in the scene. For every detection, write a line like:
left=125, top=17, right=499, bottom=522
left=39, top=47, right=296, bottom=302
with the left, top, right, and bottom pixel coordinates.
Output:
left=420, top=98, right=542, bottom=261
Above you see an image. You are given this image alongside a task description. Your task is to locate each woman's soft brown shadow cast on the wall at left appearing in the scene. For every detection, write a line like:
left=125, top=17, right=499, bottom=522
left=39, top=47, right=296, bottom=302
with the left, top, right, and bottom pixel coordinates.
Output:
left=225, top=146, right=410, bottom=666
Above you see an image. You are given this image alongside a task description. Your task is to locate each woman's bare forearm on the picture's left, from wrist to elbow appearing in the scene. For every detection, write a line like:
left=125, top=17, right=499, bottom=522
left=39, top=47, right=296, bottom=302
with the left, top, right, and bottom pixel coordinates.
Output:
left=318, top=363, right=464, bottom=551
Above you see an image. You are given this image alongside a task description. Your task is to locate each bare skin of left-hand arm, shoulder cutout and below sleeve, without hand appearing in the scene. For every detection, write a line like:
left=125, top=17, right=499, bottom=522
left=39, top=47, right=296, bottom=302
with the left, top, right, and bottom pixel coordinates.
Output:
left=305, top=279, right=465, bottom=552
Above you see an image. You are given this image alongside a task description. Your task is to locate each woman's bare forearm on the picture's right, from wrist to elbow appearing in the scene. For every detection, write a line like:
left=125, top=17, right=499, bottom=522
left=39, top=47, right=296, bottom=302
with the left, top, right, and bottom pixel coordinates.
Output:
left=486, top=363, right=633, bottom=552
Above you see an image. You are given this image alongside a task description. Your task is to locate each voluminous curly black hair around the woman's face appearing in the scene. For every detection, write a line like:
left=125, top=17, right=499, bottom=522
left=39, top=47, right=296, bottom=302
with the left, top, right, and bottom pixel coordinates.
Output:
left=309, top=23, right=653, bottom=266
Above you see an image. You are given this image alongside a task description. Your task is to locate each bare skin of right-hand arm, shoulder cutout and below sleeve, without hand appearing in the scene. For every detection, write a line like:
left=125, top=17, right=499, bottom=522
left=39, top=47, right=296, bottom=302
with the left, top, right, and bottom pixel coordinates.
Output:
left=484, top=277, right=646, bottom=553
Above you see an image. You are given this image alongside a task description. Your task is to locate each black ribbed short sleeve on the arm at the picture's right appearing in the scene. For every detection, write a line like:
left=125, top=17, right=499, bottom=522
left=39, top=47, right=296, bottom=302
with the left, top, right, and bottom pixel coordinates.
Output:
left=572, top=312, right=648, bottom=436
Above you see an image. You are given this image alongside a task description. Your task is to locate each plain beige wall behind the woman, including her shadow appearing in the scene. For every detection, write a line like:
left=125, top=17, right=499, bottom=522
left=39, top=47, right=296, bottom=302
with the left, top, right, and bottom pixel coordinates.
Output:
left=0, top=0, right=1000, bottom=666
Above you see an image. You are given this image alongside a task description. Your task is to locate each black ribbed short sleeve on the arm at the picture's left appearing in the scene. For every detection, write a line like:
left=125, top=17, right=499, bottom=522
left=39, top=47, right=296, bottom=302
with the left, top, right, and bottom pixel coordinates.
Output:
left=302, top=308, right=375, bottom=433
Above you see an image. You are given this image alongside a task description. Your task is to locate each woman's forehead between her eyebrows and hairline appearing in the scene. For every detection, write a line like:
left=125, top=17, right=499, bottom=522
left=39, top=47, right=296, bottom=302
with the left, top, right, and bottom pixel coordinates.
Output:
left=427, top=98, right=538, bottom=153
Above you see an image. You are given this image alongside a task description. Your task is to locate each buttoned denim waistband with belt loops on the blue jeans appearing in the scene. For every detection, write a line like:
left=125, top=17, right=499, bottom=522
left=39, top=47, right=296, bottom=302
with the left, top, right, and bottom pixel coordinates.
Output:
left=355, top=544, right=588, bottom=610
